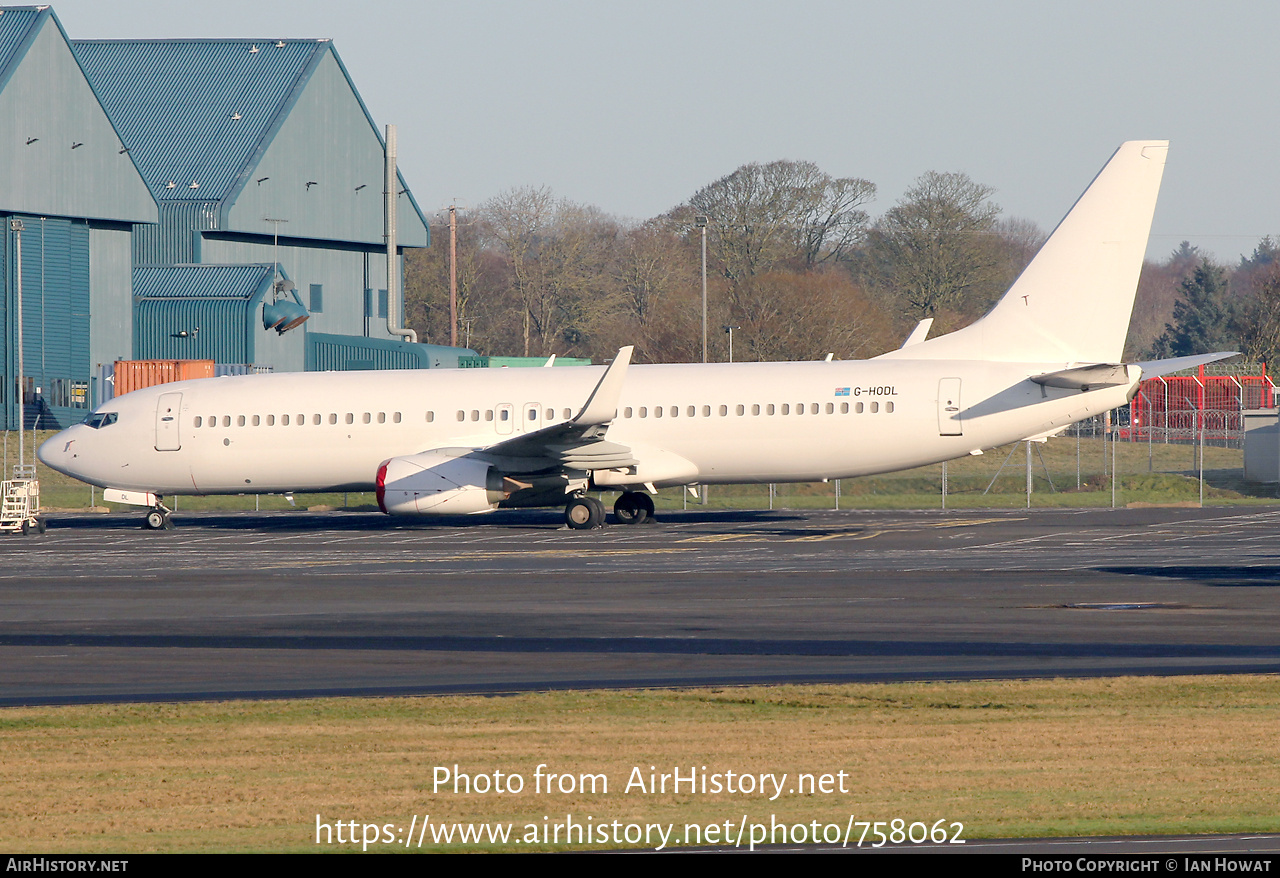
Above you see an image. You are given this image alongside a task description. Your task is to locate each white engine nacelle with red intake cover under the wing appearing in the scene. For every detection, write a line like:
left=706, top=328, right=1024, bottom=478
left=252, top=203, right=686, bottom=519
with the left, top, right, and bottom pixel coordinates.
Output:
left=378, top=449, right=504, bottom=516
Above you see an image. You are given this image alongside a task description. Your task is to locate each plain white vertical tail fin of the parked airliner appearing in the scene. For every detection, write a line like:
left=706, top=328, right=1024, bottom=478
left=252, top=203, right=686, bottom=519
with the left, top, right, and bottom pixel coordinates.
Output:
left=883, top=141, right=1169, bottom=363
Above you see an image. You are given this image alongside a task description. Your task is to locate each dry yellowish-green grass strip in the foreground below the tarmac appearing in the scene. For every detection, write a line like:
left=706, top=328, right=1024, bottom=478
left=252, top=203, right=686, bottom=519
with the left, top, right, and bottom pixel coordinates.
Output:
left=0, top=677, right=1280, bottom=852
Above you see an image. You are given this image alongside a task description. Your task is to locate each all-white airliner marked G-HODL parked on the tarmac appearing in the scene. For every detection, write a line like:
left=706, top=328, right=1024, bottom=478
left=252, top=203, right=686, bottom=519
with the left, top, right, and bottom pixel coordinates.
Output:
left=38, top=141, right=1230, bottom=529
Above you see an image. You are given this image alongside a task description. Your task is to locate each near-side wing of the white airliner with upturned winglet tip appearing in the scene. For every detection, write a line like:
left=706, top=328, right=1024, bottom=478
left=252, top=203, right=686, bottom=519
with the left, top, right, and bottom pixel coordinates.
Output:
left=483, top=344, right=639, bottom=471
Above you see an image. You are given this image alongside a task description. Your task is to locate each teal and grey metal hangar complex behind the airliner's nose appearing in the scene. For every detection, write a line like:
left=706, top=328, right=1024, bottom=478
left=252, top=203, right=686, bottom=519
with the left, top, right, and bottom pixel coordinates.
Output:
left=0, top=6, right=474, bottom=427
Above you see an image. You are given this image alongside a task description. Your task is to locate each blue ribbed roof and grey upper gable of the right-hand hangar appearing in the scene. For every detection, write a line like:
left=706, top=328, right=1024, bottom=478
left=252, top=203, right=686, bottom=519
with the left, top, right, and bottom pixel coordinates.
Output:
left=72, top=38, right=429, bottom=247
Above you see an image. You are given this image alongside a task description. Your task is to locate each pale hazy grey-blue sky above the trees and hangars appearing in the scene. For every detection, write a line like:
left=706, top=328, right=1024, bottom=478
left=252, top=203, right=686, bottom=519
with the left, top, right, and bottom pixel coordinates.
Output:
left=54, top=0, right=1280, bottom=261
